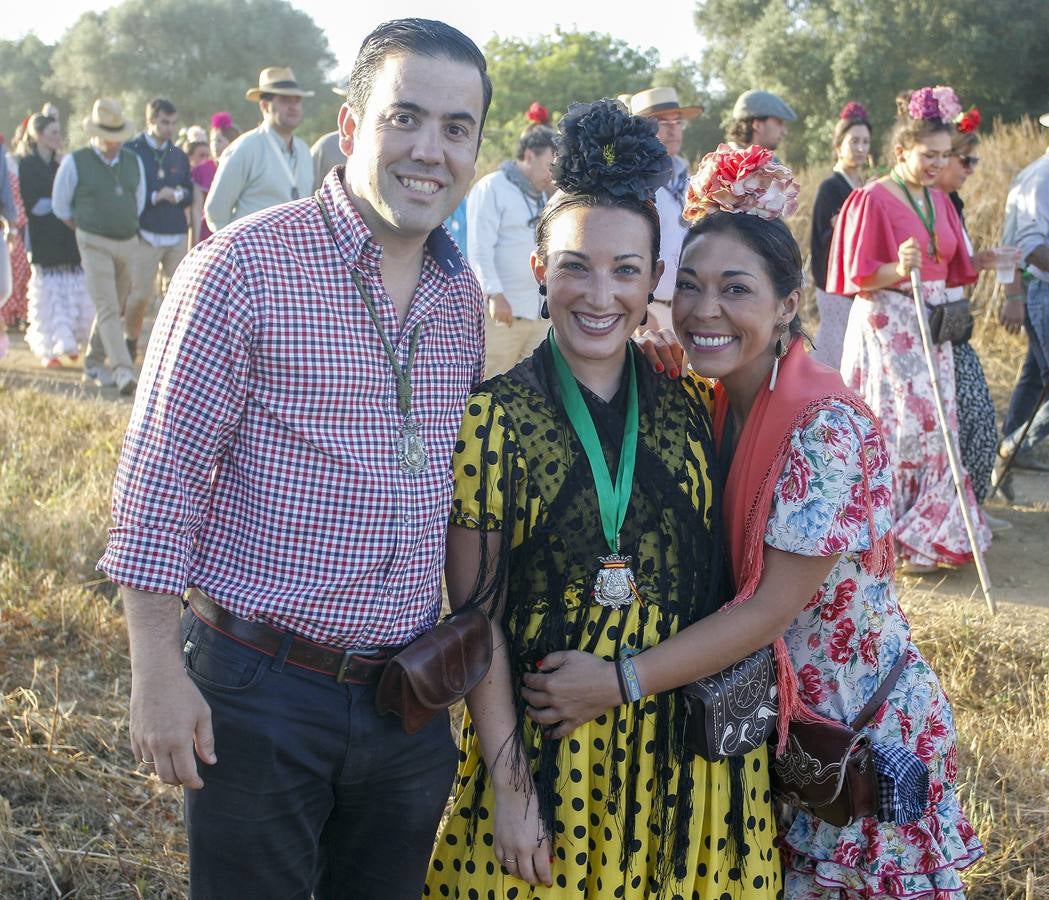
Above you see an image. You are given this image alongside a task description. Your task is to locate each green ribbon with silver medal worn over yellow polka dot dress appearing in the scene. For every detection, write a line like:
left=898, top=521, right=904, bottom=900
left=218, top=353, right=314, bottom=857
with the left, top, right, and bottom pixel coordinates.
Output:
left=550, top=331, right=641, bottom=609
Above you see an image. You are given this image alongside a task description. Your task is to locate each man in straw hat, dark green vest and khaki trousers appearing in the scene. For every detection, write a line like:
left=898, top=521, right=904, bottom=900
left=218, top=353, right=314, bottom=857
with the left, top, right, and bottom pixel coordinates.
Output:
left=51, top=98, right=146, bottom=394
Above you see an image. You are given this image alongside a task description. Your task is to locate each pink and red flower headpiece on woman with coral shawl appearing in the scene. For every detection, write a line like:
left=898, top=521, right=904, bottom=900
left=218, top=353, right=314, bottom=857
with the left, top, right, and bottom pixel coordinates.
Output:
left=682, top=144, right=798, bottom=223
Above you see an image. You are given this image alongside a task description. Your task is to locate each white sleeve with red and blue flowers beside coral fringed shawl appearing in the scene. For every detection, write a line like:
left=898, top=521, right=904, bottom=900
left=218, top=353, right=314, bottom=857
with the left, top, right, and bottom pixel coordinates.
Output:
left=765, top=400, right=893, bottom=556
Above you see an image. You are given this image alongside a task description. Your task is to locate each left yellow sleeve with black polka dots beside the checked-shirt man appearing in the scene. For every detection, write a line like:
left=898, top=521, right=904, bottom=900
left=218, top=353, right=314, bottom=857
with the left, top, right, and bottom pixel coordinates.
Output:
left=449, top=391, right=527, bottom=545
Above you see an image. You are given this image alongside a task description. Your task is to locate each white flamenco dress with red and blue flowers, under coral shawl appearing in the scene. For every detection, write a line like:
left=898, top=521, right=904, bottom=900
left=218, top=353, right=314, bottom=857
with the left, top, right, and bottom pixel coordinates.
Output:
left=765, top=401, right=983, bottom=900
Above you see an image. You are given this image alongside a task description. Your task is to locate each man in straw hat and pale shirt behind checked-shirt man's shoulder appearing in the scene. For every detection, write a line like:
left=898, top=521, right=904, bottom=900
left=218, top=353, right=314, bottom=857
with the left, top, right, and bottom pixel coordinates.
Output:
left=204, top=66, right=314, bottom=232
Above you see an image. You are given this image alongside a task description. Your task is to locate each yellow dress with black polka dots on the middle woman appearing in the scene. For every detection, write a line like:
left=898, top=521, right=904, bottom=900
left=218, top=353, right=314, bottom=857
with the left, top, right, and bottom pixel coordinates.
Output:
left=424, top=347, right=782, bottom=900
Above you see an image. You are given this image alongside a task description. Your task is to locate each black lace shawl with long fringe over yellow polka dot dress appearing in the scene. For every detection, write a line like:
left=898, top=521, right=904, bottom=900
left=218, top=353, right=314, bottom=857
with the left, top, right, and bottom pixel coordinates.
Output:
left=451, top=342, right=744, bottom=878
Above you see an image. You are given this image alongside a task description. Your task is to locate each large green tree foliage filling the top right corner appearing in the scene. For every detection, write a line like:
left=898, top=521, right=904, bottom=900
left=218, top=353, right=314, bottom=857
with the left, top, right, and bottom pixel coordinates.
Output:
left=695, top=0, right=1049, bottom=166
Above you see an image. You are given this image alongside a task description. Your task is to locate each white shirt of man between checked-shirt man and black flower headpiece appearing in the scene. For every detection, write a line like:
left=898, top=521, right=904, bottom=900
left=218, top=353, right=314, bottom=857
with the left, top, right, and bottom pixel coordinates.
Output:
left=466, top=165, right=542, bottom=319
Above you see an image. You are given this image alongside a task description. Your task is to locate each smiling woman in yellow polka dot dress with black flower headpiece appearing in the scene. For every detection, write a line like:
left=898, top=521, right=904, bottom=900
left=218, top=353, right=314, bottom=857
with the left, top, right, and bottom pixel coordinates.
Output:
left=425, top=101, right=780, bottom=900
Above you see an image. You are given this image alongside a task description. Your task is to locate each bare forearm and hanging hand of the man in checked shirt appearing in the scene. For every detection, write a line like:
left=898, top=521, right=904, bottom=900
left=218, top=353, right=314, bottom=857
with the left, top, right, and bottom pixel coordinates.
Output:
left=121, top=587, right=218, bottom=789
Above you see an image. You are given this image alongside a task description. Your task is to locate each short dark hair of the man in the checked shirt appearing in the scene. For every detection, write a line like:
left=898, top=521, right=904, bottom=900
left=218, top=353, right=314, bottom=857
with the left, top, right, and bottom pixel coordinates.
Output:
left=346, top=19, right=492, bottom=142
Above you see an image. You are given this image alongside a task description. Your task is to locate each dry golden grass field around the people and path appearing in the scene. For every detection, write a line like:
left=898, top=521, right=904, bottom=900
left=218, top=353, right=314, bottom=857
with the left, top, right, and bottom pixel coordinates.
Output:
left=0, top=124, right=1049, bottom=900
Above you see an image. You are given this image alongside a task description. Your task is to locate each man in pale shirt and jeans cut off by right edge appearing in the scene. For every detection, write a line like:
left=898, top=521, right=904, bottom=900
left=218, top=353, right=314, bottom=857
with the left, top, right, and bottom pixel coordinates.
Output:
left=996, top=112, right=1049, bottom=497
